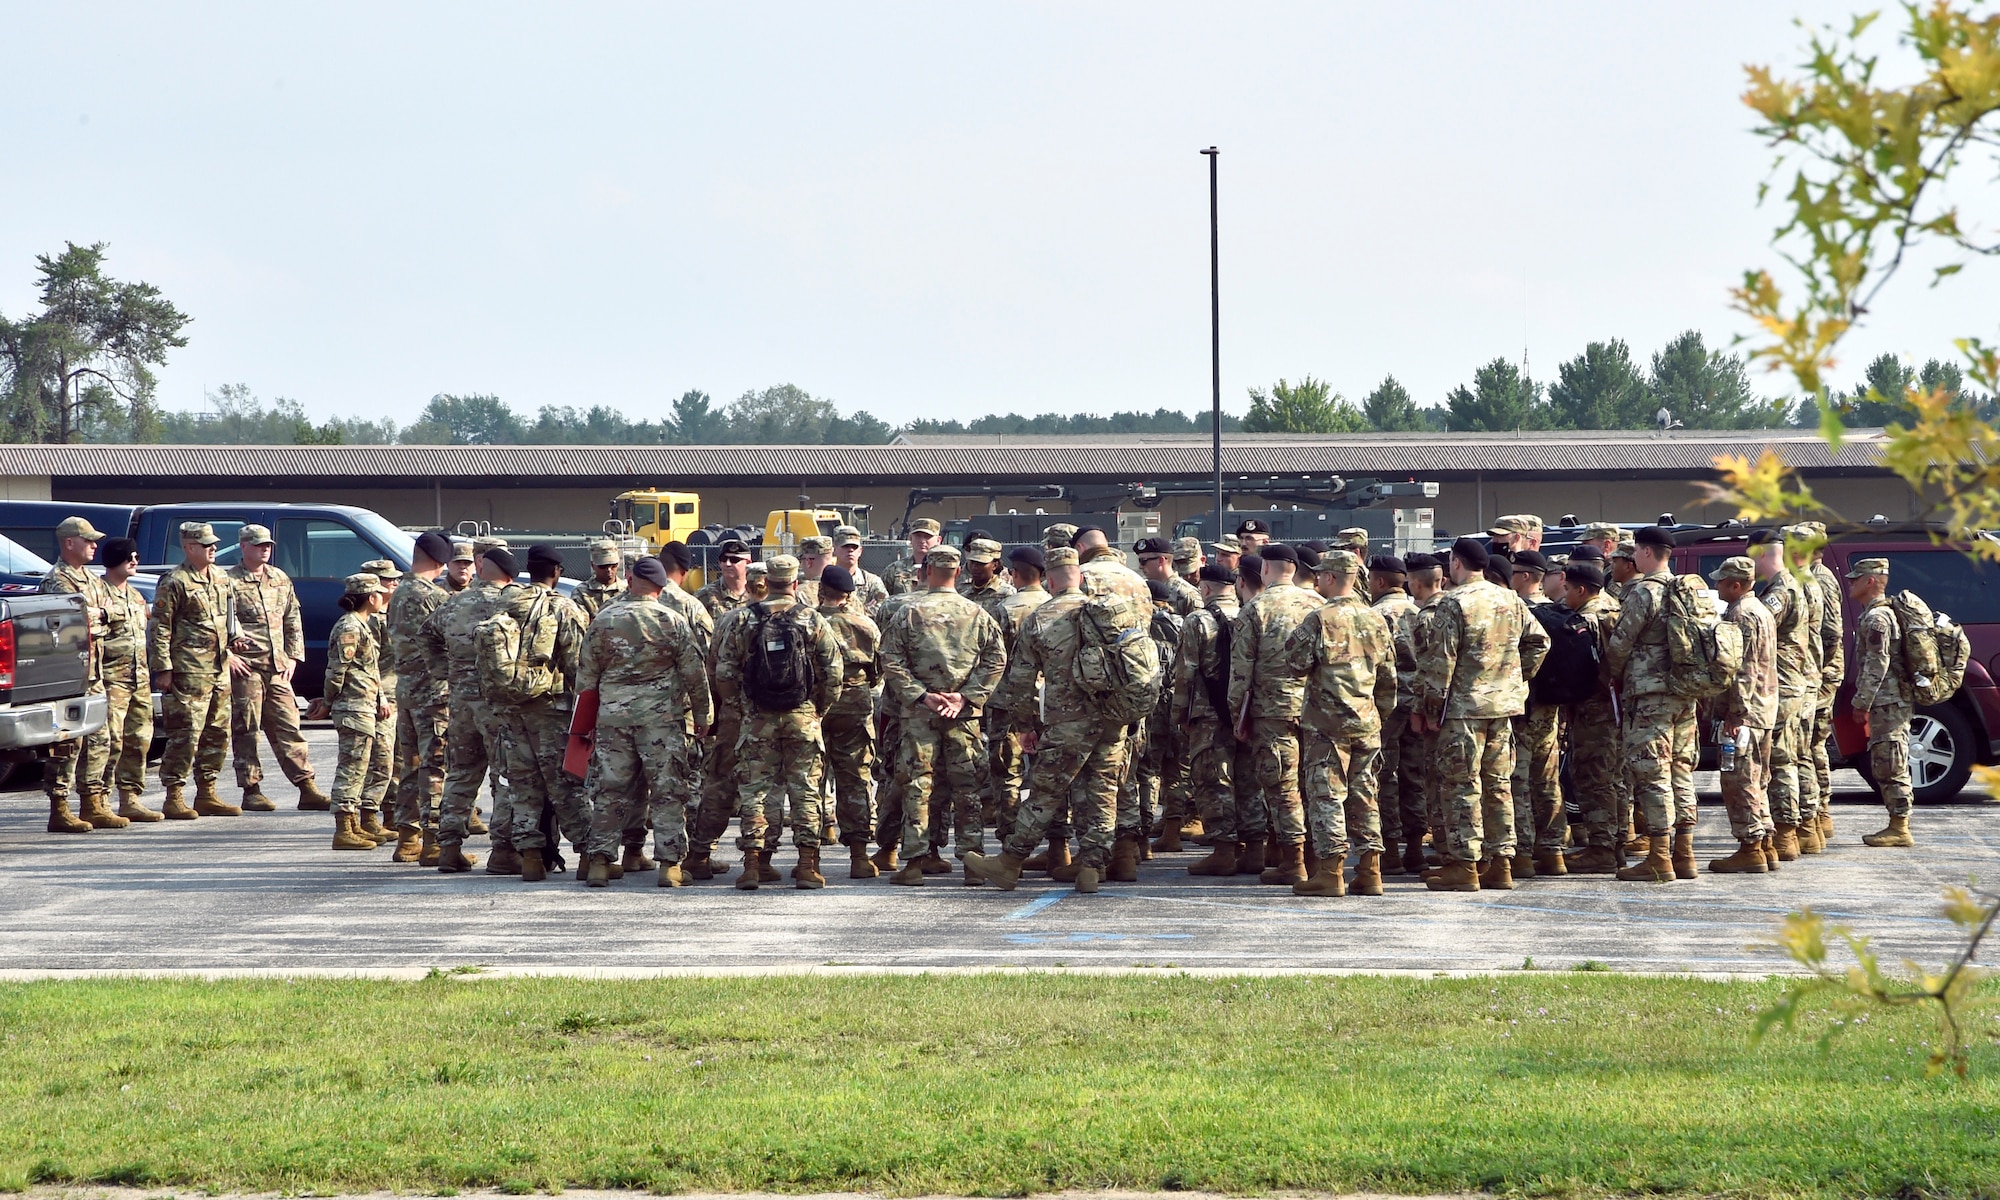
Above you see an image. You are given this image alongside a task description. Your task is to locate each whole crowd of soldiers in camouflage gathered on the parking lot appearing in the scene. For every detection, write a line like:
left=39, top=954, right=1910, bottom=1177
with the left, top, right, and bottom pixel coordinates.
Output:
left=31, top=516, right=1912, bottom=896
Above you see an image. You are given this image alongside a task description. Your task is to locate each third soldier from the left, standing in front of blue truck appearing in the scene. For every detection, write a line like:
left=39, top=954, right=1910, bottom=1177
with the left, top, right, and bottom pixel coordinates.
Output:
left=146, top=520, right=242, bottom=820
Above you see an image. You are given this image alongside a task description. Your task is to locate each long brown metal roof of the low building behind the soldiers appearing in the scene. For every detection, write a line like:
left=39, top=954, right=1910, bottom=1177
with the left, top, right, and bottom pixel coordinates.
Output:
left=0, top=430, right=1884, bottom=486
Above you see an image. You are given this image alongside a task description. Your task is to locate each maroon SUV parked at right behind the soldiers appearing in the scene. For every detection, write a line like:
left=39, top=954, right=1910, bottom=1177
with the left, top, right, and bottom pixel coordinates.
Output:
left=1674, top=526, right=2000, bottom=804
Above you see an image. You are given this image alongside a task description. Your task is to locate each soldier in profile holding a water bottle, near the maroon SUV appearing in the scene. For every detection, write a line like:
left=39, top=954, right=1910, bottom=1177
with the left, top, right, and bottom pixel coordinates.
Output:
left=1708, top=558, right=1778, bottom=874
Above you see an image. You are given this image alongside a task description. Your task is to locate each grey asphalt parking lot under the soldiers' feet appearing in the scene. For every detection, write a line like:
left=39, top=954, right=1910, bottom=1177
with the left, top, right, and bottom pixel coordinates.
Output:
left=0, top=730, right=2000, bottom=974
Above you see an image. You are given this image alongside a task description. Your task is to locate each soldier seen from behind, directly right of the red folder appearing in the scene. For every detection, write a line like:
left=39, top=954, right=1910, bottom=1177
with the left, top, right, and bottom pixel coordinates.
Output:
left=576, top=556, right=714, bottom=888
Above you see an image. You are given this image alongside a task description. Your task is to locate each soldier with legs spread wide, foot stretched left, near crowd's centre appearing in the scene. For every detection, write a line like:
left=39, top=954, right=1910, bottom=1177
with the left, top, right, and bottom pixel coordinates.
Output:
left=966, top=546, right=1126, bottom=894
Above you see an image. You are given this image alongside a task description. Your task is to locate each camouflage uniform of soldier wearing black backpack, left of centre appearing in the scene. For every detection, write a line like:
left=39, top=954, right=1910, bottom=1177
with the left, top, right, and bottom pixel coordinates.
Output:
left=716, top=594, right=842, bottom=850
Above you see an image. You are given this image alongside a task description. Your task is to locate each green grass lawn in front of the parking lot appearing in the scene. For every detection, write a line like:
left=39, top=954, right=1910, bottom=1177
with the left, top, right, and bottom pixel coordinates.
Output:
left=0, top=972, right=2000, bottom=1196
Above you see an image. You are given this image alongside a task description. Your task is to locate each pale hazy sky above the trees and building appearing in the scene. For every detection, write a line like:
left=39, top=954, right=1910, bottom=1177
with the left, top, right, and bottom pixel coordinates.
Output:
left=0, top=0, right=2000, bottom=422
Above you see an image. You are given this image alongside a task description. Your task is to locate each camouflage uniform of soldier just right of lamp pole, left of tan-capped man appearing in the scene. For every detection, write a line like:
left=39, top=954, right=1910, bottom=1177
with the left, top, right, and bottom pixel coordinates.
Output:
left=1230, top=584, right=1326, bottom=846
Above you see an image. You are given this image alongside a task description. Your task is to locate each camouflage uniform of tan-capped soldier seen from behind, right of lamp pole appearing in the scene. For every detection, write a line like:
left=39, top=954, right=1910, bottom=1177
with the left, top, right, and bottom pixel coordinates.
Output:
left=1284, top=596, right=1396, bottom=862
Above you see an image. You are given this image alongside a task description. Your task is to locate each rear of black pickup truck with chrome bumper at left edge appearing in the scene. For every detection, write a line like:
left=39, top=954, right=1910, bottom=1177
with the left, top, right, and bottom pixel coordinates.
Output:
left=0, top=594, right=108, bottom=778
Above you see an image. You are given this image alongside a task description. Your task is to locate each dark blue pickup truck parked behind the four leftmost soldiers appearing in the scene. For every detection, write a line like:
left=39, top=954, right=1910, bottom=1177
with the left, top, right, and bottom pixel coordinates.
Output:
left=0, top=500, right=416, bottom=698
